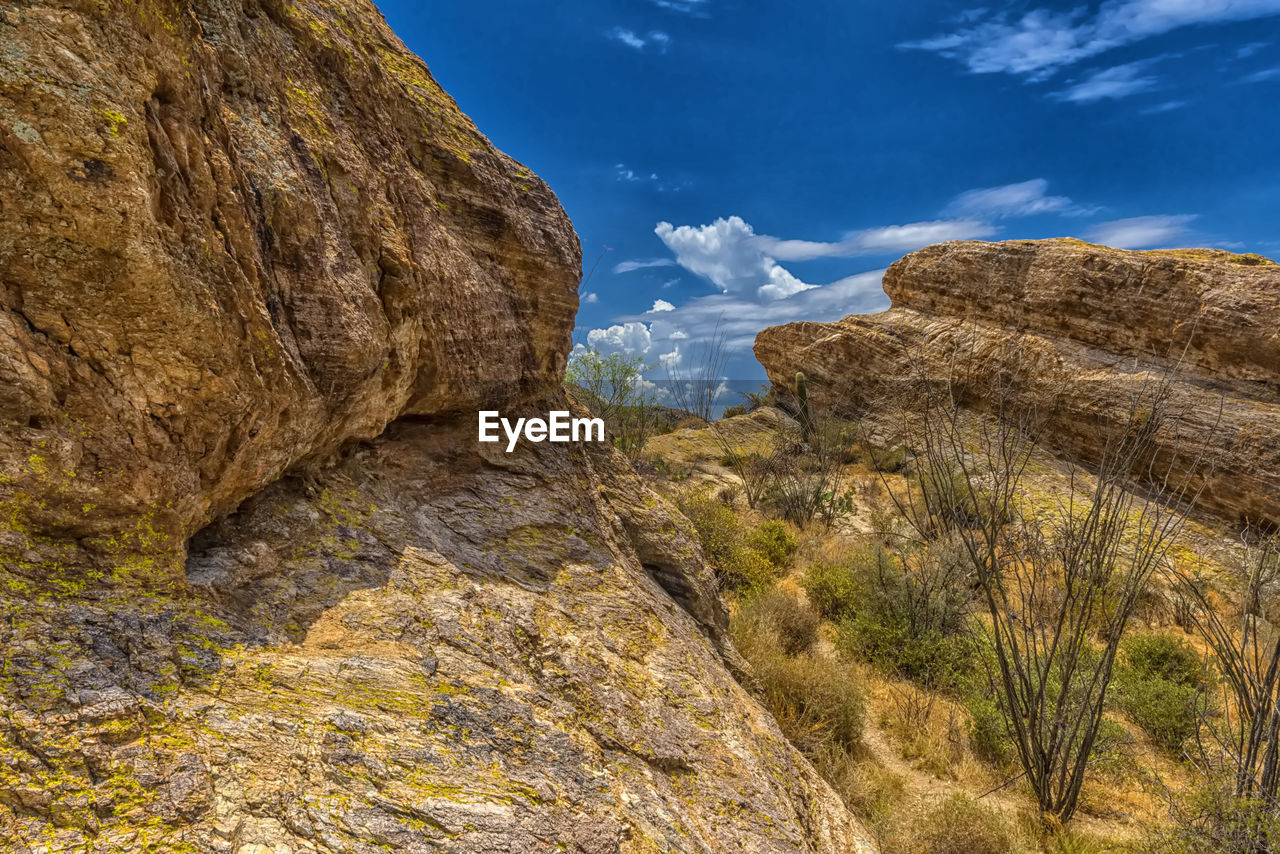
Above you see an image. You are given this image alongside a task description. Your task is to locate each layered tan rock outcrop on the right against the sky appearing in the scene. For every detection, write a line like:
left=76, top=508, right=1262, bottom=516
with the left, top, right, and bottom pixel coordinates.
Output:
left=755, top=239, right=1280, bottom=522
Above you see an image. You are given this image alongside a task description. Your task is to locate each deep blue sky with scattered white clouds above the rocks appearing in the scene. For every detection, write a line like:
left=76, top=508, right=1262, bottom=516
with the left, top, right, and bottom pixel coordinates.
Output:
left=380, top=0, right=1280, bottom=379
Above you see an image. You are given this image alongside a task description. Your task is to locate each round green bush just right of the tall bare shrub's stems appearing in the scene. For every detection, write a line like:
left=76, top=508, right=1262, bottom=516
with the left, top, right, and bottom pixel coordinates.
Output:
left=1115, top=634, right=1208, bottom=752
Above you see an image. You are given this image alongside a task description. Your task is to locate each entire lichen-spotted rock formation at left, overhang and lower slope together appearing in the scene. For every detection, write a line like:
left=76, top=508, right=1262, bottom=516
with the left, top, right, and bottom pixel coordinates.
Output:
left=0, top=0, right=863, bottom=854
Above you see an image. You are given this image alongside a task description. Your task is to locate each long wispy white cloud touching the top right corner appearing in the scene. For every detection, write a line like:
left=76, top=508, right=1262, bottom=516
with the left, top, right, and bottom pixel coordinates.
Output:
left=900, top=0, right=1280, bottom=79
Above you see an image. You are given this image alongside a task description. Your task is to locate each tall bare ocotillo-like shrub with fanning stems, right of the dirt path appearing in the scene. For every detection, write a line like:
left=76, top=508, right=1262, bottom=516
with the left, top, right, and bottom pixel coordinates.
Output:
left=875, top=332, right=1213, bottom=821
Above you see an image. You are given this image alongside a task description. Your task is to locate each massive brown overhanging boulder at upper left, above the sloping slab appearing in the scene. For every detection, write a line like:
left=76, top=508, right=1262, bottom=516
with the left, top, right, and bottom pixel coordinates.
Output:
left=0, top=0, right=580, bottom=575
